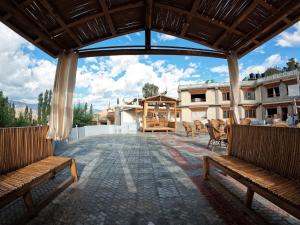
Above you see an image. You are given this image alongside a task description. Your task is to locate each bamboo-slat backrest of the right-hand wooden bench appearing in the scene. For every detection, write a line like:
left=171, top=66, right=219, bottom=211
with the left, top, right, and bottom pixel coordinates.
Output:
left=230, top=125, right=300, bottom=180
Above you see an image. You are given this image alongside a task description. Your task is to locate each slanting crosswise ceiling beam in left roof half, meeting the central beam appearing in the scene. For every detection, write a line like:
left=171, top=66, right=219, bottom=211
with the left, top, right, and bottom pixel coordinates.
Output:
left=50, top=0, right=144, bottom=35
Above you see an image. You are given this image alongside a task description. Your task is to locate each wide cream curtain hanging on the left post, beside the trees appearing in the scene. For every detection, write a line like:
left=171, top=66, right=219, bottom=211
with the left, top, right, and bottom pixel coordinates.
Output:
left=48, top=52, right=78, bottom=140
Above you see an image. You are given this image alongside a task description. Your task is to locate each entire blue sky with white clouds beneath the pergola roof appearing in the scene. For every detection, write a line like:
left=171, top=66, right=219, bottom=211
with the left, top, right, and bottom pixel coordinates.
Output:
left=0, top=22, right=300, bottom=109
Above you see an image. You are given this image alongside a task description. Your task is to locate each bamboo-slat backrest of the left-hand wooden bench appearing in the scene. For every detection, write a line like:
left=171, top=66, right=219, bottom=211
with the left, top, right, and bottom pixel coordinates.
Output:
left=0, top=126, right=53, bottom=175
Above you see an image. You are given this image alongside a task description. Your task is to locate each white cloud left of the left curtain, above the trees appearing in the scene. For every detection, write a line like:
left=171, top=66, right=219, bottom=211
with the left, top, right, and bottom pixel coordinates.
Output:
left=0, top=23, right=56, bottom=103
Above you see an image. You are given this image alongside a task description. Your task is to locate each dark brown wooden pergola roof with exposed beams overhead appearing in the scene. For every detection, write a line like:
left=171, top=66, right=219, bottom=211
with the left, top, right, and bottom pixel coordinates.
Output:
left=0, top=0, right=300, bottom=57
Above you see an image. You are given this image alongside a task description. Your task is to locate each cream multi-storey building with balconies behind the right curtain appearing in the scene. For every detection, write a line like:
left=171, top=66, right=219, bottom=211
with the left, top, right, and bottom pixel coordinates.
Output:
left=178, top=70, right=300, bottom=122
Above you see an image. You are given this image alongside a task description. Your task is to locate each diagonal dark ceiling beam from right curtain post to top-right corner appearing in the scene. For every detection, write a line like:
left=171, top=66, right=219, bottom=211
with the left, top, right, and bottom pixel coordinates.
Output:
left=233, top=1, right=300, bottom=52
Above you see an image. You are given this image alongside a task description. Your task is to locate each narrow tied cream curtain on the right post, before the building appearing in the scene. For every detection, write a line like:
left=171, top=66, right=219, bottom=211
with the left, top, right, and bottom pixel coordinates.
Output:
left=227, top=53, right=240, bottom=124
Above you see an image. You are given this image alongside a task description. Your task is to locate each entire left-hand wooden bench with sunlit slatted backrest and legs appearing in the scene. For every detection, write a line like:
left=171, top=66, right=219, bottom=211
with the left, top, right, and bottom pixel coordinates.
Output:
left=0, top=127, right=78, bottom=222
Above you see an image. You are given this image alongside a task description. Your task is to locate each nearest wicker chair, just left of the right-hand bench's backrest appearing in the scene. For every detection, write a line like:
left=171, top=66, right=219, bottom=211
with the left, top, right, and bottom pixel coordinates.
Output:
left=207, top=120, right=227, bottom=151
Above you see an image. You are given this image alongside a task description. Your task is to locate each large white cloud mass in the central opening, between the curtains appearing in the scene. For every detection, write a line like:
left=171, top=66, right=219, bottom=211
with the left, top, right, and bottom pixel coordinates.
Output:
left=75, top=56, right=200, bottom=108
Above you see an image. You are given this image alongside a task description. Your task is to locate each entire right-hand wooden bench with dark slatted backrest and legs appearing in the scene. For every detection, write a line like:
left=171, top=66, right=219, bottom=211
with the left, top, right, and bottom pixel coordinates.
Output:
left=203, top=125, right=300, bottom=219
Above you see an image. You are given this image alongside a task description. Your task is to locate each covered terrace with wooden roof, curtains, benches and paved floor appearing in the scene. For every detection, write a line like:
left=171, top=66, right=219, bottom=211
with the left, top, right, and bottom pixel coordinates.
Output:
left=0, top=0, right=300, bottom=224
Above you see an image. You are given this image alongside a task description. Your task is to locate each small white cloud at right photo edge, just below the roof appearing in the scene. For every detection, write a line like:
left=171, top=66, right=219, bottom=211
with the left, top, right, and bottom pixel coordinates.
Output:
left=276, top=22, right=300, bottom=47
